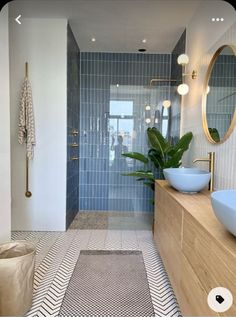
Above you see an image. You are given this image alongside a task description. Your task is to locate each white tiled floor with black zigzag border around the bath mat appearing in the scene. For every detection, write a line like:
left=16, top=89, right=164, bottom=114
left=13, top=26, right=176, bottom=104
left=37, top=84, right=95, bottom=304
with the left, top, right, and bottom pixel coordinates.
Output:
left=12, top=230, right=181, bottom=317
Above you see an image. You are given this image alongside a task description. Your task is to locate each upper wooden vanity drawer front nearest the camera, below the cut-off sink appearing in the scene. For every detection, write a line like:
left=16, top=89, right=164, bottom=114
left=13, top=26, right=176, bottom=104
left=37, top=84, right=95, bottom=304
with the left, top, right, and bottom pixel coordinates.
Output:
left=183, top=212, right=236, bottom=316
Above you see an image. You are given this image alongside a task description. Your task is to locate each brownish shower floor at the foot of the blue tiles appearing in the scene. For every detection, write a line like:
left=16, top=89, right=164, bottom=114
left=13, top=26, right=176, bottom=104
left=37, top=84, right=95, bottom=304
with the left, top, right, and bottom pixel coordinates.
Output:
left=70, top=211, right=153, bottom=230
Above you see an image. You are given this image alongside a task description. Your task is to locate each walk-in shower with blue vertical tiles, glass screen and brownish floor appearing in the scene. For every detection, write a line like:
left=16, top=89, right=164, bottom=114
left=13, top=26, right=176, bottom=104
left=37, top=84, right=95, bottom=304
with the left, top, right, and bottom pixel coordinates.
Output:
left=67, top=26, right=185, bottom=229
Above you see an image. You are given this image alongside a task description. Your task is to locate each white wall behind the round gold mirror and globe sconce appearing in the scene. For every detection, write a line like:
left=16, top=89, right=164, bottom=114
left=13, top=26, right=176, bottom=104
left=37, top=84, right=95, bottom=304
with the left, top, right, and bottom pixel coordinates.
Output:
left=181, top=1, right=236, bottom=189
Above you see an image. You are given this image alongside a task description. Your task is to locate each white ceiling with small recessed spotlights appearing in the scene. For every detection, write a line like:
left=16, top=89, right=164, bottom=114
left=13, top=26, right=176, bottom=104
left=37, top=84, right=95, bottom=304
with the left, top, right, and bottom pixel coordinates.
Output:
left=9, top=0, right=204, bottom=53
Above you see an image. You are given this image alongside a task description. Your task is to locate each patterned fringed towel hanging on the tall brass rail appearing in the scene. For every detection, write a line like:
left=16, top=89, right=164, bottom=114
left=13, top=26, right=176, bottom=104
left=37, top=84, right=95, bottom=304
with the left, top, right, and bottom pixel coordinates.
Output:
left=18, top=77, right=35, bottom=159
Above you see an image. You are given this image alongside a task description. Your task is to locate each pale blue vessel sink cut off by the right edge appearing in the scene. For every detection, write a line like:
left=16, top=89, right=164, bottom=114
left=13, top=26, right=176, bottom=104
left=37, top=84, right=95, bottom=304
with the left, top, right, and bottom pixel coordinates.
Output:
left=211, top=189, right=236, bottom=236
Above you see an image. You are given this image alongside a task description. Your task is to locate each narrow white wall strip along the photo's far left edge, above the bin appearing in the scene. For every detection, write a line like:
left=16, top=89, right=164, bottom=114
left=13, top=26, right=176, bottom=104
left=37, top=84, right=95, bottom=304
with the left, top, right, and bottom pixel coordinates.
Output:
left=0, top=5, right=11, bottom=243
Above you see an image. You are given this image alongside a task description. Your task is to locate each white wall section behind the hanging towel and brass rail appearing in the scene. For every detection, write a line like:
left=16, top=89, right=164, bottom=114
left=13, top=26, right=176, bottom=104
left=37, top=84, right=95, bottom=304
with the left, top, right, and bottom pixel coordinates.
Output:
left=10, top=19, right=67, bottom=231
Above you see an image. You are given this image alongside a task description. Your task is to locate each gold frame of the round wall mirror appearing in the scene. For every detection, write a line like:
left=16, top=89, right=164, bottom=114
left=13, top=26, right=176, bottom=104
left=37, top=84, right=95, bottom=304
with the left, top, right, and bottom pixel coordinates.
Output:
left=202, top=44, right=236, bottom=144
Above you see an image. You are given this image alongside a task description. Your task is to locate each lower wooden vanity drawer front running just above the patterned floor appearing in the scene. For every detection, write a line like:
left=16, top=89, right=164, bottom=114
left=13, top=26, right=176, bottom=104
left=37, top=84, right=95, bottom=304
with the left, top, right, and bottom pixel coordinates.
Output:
left=154, top=213, right=218, bottom=316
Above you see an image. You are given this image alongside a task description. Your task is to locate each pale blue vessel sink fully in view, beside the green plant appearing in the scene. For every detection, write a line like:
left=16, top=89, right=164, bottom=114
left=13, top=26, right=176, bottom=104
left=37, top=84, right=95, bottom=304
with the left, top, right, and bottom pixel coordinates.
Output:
left=163, top=167, right=211, bottom=193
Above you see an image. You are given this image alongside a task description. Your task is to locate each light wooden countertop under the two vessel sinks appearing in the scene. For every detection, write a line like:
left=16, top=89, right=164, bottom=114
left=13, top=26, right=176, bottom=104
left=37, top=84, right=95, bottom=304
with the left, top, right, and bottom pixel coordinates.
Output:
left=155, top=180, right=236, bottom=260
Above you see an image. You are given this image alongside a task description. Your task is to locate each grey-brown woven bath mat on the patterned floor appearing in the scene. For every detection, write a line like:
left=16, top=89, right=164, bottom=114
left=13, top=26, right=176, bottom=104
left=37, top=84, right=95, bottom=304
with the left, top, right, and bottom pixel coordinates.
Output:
left=59, top=250, right=154, bottom=317
